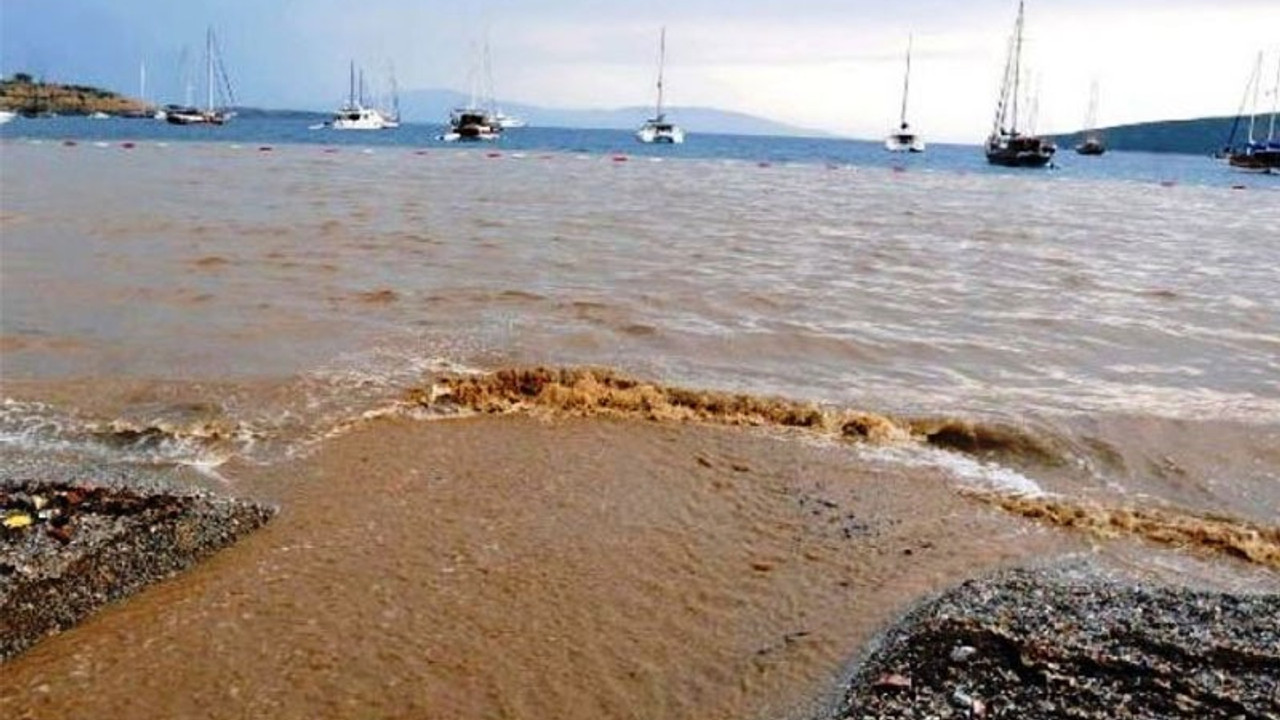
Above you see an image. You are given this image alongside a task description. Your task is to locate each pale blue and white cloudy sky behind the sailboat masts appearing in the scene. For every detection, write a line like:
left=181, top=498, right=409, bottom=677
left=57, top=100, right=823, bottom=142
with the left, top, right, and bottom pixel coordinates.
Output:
left=0, top=0, right=1280, bottom=142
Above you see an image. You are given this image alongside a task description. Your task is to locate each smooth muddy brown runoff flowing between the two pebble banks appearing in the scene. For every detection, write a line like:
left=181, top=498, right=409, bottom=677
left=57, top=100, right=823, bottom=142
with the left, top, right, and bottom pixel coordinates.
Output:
left=0, top=416, right=1082, bottom=719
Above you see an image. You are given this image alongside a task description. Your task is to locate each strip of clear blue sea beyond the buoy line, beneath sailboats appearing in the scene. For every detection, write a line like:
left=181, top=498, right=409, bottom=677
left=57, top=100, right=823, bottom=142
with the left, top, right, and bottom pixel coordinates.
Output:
left=0, top=118, right=1280, bottom=190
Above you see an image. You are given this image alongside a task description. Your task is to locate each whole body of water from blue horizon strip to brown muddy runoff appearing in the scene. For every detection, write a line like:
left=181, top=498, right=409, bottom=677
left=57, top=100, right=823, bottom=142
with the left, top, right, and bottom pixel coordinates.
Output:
left=0, top=118, right=1280, bottom=717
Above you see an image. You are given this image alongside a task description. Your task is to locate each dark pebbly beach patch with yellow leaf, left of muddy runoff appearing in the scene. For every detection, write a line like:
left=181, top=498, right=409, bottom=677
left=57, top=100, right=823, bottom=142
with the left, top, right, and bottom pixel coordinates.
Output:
left=0, top=478, right=275, bottom=662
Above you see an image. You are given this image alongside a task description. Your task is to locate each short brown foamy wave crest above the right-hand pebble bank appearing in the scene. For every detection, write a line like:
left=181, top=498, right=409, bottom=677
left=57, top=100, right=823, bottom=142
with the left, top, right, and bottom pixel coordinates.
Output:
left=961, top=489, right=1280, bottom=569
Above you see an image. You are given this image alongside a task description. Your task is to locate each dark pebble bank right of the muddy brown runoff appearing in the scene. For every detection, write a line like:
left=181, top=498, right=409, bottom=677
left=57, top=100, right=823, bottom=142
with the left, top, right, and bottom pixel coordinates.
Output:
left=824, top=566, right=1280, bottom=720
